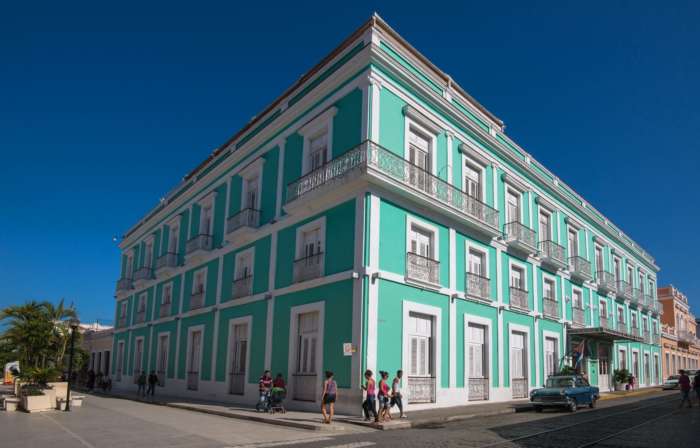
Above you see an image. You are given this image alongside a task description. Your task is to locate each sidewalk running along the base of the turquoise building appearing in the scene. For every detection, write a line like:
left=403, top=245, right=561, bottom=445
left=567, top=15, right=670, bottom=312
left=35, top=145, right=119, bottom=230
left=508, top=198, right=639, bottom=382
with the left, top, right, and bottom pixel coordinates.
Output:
left=83, top=388, right=660, bottom=434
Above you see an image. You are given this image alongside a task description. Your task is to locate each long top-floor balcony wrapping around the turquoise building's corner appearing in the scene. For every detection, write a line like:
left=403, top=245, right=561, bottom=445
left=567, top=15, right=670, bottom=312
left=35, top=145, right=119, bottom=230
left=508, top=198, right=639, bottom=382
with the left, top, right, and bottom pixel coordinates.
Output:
left=285, top=141, right=500, bottom=237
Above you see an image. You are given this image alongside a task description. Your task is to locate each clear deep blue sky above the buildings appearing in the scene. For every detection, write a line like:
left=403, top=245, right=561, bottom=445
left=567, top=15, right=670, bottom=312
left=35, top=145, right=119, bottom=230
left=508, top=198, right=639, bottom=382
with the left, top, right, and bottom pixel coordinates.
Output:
left=0, top=1, right=700, bottom=320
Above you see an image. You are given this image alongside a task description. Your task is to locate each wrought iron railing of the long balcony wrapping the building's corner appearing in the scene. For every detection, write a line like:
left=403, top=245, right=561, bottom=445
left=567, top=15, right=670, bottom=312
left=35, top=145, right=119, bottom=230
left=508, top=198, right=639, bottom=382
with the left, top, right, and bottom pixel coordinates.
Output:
left=285, top=140, right=498, bottom=234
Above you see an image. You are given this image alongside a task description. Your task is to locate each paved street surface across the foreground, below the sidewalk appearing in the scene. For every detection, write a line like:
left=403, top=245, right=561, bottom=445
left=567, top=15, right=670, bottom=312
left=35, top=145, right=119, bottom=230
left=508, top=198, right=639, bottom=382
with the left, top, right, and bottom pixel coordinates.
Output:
left=0, top=392, right=700, bottom=448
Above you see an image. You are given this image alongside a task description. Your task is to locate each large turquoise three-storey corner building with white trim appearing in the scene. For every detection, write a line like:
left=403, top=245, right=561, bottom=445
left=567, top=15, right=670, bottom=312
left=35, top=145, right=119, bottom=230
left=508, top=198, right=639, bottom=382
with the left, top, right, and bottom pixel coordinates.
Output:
left=112, top=16, right=661, bottom=412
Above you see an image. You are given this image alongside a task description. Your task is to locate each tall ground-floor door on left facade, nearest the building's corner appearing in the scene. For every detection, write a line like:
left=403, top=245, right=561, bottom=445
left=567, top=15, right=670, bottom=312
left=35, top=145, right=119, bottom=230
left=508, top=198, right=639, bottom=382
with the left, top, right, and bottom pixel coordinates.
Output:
left=294, top=311, right=319, bottom=401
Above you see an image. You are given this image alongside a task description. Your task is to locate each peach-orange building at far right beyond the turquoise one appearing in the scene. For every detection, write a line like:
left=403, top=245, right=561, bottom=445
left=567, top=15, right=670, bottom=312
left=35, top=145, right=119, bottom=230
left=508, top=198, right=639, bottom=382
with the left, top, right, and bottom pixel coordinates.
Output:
left=657, top=285, right=700, bottom=378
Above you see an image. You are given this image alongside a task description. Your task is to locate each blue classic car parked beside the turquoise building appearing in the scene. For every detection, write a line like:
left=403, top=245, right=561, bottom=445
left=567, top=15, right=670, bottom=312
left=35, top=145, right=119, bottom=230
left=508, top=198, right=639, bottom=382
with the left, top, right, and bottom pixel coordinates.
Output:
left=530, top=375, right=600, bottom=412
